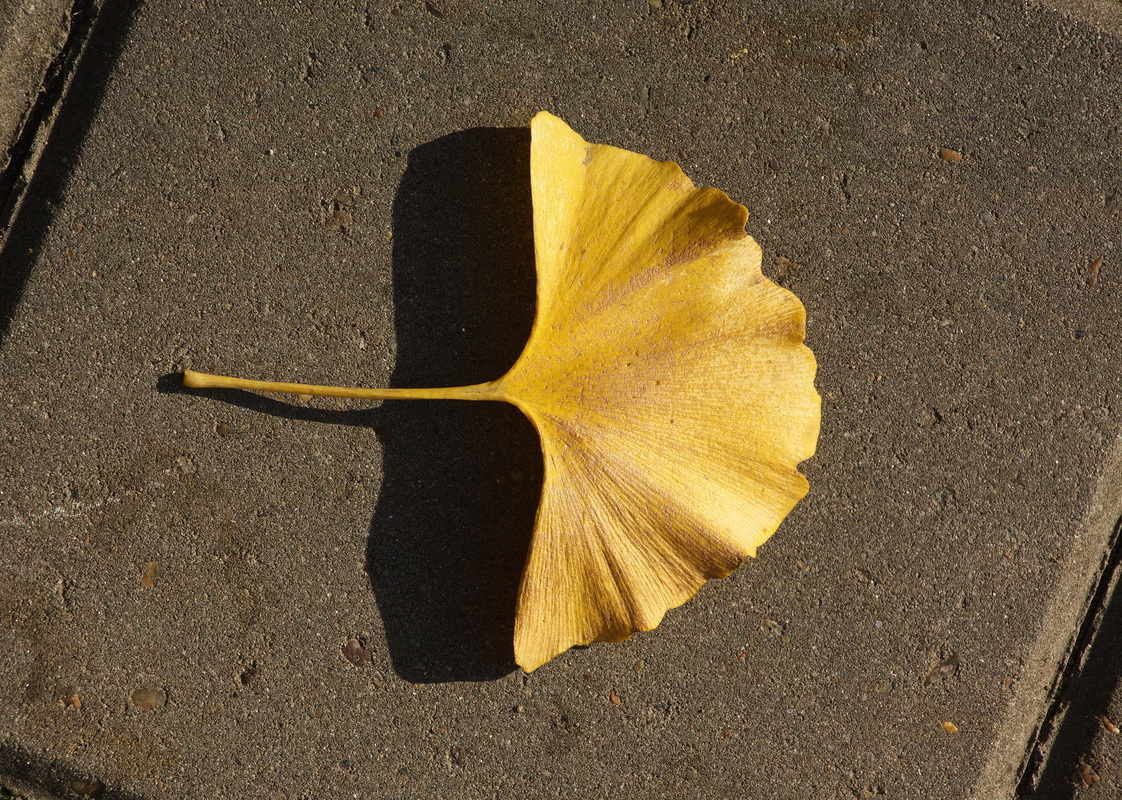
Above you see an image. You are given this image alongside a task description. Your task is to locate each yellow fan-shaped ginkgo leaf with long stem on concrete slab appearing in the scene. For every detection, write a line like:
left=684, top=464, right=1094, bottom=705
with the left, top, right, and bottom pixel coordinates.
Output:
left=184, top=112, right=820, bottom=671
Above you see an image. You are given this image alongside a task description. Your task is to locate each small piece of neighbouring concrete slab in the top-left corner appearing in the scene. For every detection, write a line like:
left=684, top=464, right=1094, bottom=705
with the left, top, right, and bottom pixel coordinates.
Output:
left=0, top=0, right=73, bottom=174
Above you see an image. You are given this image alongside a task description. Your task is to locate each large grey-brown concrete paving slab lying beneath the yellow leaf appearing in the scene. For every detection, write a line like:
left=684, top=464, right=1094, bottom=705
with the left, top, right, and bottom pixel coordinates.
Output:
left=0, top=0, right=1122, bottom=799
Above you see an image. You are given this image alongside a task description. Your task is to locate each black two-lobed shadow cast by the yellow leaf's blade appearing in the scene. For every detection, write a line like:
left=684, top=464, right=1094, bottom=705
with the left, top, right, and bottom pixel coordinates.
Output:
left=367, top=128, right=542, bottom=682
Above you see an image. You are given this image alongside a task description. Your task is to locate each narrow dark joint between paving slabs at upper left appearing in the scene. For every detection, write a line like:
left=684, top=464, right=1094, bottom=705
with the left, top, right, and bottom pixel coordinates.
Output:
left=0, top=0, right=100, bottom=242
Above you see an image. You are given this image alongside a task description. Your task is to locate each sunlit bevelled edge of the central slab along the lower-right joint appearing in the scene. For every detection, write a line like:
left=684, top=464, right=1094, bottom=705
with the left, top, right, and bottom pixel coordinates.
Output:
left=974, top=436, right=1122, bottom=798
